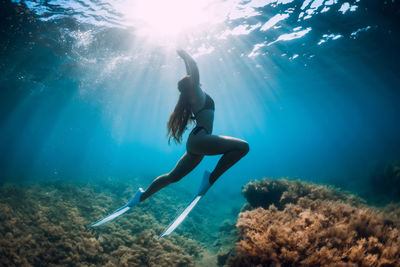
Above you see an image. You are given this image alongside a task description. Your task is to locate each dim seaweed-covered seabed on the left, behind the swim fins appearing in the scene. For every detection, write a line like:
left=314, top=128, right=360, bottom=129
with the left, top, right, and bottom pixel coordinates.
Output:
left=0, top=183, right=203, bottom=266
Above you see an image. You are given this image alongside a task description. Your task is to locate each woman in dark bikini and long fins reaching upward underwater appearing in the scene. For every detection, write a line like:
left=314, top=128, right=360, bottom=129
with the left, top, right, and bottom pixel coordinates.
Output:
left=90, top=50, right=249, bottom=232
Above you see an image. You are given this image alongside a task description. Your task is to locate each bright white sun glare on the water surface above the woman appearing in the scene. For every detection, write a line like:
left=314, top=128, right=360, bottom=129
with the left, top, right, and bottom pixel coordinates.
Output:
left=126, top=0, right=224, bottom=39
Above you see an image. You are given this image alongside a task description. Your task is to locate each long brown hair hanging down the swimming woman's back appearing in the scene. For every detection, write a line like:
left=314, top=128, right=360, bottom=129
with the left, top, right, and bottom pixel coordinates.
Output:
left=167, top=76, right=193, bottom=144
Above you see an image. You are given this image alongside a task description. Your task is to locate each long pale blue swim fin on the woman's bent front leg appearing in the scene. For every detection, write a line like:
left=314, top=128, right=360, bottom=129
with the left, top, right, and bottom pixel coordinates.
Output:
left=158, top=171, right=211, bottom=239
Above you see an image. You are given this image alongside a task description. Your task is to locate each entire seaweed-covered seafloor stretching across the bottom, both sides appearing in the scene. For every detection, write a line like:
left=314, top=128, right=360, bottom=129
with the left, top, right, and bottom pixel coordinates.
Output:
left=0, top=179, right=400, bottom=266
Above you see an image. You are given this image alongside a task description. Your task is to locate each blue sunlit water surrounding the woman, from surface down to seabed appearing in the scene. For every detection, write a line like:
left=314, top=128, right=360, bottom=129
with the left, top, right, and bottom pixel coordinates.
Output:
left=0, top=0, right=400, bottom=221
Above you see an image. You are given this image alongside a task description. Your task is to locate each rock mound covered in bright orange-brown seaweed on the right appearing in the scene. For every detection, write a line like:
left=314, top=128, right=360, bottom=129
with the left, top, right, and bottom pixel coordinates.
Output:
left=226, top=179, right=400, bottom=266
